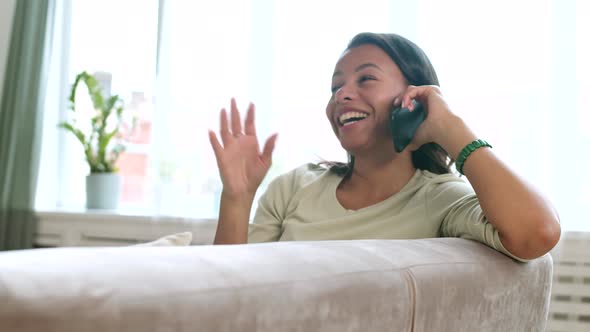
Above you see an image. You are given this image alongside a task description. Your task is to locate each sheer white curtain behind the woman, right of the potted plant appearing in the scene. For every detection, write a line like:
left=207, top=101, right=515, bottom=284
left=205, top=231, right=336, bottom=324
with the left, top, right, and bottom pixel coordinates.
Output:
left=155, top=0, right=590, bottom=230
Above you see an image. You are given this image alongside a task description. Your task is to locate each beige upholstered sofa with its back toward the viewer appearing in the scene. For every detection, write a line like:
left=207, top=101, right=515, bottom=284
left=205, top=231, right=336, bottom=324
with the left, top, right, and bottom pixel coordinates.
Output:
left=0, top=238, right=552, bottom=332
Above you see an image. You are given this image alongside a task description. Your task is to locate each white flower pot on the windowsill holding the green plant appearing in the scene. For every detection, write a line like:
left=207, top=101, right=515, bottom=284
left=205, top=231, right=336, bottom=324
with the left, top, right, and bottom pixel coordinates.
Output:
left=86, top=173, right=121, bottom=210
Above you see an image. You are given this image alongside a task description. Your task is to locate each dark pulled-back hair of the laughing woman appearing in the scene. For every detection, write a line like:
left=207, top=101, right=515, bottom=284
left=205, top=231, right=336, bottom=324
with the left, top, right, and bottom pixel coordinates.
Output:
left=319, top=32, right=455, bottom=178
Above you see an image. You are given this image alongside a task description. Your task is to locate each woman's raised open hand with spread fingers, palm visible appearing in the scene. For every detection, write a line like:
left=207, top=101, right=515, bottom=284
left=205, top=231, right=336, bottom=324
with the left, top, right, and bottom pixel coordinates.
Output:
left=209, top=98, right=277, bottom=197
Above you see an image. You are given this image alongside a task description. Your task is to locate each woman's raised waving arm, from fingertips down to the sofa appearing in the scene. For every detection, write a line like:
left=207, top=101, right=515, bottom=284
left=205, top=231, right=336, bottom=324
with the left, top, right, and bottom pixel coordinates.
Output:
left=209, top=99, right=277, bottom=244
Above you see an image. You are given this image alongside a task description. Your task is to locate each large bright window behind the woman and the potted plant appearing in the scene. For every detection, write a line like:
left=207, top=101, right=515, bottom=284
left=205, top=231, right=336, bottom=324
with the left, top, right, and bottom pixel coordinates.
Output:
left=42, top=0, right=590, bottom=230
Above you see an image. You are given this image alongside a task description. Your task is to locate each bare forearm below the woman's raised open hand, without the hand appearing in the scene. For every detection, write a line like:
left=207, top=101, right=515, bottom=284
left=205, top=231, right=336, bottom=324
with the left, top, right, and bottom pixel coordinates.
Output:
left=213, top=192, right=254, bottom=244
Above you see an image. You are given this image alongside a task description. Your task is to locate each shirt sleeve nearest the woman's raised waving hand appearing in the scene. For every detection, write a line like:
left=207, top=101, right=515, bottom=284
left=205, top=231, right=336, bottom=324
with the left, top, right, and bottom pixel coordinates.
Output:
left=248, top=172, right=294, bottom=243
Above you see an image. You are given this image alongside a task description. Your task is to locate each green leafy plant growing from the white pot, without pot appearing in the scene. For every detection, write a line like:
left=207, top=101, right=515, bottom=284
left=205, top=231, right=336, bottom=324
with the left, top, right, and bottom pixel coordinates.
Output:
left=58, top=71, right=125, bottom=173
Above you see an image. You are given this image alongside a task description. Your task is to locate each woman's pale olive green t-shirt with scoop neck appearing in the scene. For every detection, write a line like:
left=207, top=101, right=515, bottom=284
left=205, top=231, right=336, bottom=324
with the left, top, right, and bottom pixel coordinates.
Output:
left=248, top=164, right=525, bottom=261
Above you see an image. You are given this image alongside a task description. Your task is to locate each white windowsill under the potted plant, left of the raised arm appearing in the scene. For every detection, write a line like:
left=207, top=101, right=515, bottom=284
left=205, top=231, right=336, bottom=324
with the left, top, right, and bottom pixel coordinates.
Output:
left=35, top=208, right=217, bottom=247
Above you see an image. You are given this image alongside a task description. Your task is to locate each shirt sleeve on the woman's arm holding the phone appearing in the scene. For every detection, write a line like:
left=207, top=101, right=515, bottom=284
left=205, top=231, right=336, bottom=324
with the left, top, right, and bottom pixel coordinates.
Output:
left=426, top=179, right=527, bottom=262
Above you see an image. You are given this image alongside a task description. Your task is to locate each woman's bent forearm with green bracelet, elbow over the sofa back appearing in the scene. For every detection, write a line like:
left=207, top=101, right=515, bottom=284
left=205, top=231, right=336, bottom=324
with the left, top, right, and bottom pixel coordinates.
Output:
left=439, top=118, right=560, bottom=259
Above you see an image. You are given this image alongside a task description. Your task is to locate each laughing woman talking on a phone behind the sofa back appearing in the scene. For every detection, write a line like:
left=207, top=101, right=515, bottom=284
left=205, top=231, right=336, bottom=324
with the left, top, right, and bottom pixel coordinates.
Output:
left=209, top=33, right=560, bottom=261
